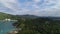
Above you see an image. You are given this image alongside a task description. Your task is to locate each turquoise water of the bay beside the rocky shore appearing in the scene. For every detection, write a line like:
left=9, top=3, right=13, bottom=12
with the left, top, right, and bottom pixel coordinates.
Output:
left=0, top=21, right=15, bottom=34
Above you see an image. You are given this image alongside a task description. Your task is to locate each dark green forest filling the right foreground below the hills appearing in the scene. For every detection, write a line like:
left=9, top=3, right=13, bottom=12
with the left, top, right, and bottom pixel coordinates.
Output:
left=13, top=17, right=60, bottom=34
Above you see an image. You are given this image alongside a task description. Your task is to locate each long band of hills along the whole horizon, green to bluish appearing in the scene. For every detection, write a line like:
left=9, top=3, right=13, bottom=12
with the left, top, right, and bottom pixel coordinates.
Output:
left=0, top=12, right=60, bottom=20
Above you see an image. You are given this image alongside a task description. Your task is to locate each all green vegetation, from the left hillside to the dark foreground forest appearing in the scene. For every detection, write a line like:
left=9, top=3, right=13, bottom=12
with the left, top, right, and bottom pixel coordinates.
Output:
left=0, top=13, right=60, bottom=34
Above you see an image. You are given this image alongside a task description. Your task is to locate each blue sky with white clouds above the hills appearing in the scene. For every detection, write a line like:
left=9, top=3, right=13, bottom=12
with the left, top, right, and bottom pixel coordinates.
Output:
left=0, top=0, right=60, bottom=17
